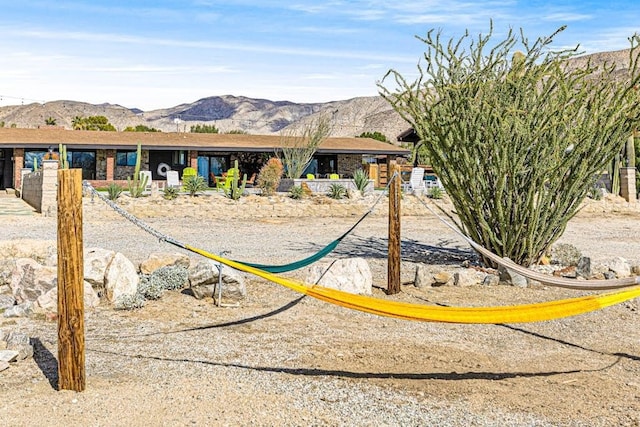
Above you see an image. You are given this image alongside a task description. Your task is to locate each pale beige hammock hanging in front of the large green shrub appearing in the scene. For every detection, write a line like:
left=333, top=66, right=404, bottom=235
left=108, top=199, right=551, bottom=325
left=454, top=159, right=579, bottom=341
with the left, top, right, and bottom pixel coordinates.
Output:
left=414, top=194, right=640, bottom=291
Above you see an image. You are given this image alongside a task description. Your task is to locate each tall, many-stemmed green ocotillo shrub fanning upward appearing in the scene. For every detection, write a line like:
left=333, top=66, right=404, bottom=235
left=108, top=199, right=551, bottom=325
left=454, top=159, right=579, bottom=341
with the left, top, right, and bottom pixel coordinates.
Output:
left=379, top=28, right=640, bottom=265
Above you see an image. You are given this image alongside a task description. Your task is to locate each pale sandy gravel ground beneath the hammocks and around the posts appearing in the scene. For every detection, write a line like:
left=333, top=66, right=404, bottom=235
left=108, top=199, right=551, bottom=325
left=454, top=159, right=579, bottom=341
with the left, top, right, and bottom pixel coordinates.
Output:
left=0, top=192, right=640, bottom=426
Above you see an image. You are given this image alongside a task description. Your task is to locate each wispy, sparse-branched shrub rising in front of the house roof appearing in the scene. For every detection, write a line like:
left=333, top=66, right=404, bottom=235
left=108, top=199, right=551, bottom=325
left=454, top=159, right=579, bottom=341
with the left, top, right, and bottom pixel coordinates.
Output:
left=280, top=116, right=331, bottom=179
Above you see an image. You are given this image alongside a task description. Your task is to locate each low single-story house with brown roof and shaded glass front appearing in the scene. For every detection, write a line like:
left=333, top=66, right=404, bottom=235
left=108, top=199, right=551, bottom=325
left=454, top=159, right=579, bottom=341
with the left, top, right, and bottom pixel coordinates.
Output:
left=0, top=128, right=410, bottom=189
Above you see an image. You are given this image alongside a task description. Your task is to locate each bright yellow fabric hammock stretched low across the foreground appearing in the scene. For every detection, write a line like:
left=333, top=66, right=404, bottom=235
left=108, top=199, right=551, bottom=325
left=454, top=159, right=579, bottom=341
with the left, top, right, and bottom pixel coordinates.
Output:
left=184, top=245, right=640, bottom=324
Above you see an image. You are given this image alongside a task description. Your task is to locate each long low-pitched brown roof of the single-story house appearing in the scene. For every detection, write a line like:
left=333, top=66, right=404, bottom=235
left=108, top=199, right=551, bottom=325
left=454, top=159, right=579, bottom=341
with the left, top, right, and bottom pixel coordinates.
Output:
left=0, top=128, right=409, bottom=156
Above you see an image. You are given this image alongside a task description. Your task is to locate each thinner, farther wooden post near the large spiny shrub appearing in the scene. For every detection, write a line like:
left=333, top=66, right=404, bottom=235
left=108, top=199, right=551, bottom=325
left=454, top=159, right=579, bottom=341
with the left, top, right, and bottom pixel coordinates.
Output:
left=387, top=162, right=401, bottom=295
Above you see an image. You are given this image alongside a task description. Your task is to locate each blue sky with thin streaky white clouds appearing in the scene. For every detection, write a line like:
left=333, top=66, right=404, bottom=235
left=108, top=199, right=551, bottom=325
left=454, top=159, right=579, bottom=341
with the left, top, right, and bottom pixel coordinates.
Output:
left=0, top=0, right=640, bottom=111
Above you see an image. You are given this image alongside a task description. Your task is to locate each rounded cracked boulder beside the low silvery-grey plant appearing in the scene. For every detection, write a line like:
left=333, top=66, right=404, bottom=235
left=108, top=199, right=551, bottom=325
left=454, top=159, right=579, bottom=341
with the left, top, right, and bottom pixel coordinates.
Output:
left=189, top=260, right=247, bottom=301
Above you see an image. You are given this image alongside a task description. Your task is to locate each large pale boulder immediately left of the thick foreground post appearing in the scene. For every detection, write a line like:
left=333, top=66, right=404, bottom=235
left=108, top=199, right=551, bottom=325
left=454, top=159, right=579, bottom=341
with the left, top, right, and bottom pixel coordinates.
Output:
left=10, top=258, right=58, bottom=304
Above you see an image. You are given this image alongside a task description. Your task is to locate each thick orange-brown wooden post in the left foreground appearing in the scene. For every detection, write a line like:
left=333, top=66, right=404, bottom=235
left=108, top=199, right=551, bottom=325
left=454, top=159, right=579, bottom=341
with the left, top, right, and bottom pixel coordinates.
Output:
left=58, top=169, right=85, bottom=391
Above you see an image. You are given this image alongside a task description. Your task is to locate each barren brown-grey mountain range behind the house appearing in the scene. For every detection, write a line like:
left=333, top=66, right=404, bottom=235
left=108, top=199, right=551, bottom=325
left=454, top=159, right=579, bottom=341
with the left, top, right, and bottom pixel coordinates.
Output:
left=0, top=49, right=629, bottom=142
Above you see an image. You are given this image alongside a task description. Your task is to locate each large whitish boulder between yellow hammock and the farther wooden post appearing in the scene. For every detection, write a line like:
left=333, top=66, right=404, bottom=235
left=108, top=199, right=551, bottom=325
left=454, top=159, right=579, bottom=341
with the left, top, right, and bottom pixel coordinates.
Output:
left=305, top=258, right=373, bottom=295
